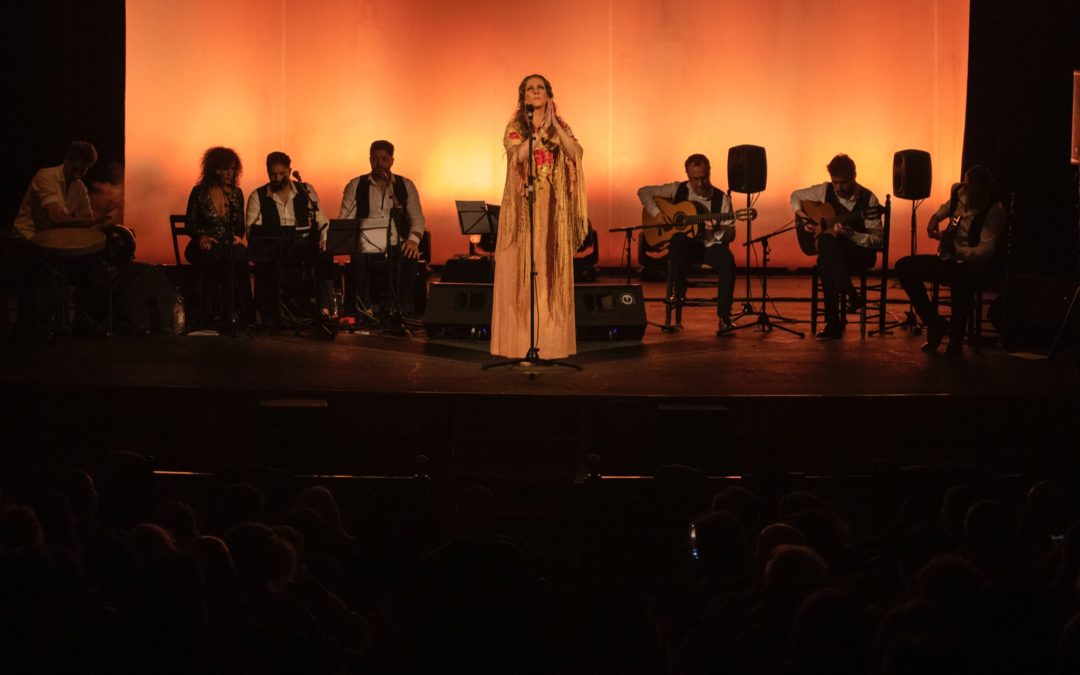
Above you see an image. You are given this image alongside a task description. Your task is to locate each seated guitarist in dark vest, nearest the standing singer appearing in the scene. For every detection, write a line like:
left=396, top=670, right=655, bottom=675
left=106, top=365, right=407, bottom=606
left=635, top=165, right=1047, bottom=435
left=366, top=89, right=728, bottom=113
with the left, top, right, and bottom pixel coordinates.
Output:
left=637, top=153, right=735, bottom=333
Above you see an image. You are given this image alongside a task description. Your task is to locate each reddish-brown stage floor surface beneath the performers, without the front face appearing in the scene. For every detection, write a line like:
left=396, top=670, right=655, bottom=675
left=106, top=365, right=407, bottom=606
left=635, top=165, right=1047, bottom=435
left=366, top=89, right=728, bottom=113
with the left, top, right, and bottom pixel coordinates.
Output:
left=0, top=276, right=1077, bottom=396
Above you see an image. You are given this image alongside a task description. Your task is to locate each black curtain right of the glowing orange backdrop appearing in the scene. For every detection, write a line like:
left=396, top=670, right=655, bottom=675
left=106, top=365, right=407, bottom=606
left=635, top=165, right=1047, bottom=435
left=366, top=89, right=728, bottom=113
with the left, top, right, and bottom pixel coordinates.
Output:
left=967, top=0, right=1080, bottom=276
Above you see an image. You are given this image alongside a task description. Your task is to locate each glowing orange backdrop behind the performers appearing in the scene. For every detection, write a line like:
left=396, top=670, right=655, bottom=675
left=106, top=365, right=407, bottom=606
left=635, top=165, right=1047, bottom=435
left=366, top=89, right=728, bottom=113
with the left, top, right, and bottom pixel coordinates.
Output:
left=126, top=0, right=968, bottom=267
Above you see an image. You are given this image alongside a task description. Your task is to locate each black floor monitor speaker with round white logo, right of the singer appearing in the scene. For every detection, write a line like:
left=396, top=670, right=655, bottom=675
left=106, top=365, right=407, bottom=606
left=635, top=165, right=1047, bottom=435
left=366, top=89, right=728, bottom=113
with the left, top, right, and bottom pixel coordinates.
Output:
left=573, top=284, right=646, bottom=340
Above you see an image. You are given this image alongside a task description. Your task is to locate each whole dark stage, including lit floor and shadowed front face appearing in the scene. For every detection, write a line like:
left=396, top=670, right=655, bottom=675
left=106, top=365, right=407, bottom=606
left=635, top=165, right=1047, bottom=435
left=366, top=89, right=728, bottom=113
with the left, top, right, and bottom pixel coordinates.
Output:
left=0, top=276, right=1080, bottom=480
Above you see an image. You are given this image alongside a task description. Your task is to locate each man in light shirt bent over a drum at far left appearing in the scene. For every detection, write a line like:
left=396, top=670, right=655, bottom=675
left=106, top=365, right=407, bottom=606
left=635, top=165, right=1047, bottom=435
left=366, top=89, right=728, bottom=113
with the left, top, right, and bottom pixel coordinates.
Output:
left=10, top=140, right=112, bottom=339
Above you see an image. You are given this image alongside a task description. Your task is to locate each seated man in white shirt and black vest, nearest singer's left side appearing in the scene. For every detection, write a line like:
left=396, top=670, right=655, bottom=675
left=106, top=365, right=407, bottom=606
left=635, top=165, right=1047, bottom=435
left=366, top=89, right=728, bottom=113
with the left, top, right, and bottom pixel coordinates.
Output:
left=338, top=140, right=424, bottom=315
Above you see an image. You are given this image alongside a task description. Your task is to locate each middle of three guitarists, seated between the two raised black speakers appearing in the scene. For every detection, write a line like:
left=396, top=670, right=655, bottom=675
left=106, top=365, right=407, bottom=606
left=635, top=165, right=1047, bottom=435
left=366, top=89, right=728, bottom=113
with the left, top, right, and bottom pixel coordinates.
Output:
left=792, top=154, right=885, bottom=340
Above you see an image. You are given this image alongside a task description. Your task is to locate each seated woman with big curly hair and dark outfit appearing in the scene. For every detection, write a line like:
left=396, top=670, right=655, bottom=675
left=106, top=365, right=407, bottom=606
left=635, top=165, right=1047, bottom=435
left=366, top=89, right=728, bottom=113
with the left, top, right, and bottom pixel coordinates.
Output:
left=184, top=147, right=254, bottom=321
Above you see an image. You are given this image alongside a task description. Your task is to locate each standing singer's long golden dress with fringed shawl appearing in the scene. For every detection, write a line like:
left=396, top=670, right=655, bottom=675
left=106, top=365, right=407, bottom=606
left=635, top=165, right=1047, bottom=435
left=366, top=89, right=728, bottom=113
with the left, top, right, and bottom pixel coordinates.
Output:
left=491, top=120, right=589, bottom=359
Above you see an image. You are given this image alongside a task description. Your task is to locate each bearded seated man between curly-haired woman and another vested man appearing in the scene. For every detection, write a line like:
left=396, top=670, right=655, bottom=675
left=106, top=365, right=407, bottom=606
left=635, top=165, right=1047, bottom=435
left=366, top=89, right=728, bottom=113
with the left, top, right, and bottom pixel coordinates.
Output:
left=245, top=151, right=329, bottom=327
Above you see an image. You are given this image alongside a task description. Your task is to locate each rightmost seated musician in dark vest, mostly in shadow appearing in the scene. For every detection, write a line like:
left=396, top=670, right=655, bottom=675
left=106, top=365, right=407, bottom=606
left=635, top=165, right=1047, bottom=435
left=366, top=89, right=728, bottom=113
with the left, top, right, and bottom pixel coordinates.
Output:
left=896, top=165, right=1007, bottom=356
